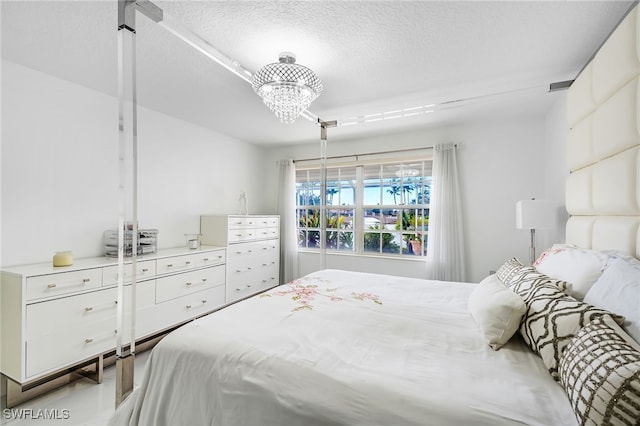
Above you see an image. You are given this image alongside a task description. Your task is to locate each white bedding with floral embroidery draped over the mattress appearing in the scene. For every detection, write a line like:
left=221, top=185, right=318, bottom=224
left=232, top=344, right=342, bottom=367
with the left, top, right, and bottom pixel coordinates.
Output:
left=111, top=270, right=576, bottom=426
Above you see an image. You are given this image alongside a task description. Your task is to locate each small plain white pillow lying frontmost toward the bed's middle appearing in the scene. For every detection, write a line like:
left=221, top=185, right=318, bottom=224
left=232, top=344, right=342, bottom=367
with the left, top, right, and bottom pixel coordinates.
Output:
left=468, top=274, right=527, bottom=350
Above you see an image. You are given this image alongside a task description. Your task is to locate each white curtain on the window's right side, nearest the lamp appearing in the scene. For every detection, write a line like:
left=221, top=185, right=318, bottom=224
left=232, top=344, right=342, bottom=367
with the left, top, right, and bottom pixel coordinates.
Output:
left=426, top=144, right=466, bottom=281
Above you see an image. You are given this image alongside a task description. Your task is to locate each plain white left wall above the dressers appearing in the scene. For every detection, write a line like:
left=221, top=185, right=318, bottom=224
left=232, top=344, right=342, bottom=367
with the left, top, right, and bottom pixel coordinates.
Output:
left=1, top=61, right=273, bottom=266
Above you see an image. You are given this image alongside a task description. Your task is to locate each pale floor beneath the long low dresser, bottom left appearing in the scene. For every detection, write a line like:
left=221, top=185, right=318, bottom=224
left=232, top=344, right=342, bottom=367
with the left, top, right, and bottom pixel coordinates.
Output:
left=0, top=351, right=151, bottom=426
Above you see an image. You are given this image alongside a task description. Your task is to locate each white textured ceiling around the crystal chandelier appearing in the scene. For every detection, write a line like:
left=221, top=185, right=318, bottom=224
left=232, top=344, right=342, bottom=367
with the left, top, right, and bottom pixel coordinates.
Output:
left=2, top=0, right=633, bottom=144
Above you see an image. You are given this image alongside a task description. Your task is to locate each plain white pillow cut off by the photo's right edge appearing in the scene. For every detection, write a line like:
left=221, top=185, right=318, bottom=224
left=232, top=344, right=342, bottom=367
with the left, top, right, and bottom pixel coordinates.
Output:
left=584, top=258, right=640, bottom=343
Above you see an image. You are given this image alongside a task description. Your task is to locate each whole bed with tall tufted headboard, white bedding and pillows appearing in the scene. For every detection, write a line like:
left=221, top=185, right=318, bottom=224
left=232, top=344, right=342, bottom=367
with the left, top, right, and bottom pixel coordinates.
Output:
left=110, top=8, right=640, bottom=425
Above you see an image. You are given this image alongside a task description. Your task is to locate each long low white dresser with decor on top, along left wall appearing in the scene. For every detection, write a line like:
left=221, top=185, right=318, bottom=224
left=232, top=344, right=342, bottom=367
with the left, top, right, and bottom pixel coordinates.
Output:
left=0, top=246, right=226, bottom=384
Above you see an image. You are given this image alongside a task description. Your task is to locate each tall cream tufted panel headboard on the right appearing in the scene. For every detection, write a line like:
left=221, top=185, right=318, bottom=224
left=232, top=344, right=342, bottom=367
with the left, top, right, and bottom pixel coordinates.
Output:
left=566, top=6, right=640, bottom=258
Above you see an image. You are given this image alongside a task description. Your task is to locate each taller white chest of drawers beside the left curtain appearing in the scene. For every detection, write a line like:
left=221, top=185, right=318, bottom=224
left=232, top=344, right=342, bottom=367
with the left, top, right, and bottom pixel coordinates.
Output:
left=200, top=215, right=280, bottom=303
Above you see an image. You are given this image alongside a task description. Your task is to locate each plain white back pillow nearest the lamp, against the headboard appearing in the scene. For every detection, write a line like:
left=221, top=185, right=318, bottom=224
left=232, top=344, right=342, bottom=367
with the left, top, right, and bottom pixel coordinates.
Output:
left=533, top=244, right=608, bottom=300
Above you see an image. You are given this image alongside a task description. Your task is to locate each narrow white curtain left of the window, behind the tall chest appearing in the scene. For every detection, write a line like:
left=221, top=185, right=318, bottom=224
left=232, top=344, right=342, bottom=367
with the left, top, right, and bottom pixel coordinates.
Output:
left=278, top=159, right=298, bottom=283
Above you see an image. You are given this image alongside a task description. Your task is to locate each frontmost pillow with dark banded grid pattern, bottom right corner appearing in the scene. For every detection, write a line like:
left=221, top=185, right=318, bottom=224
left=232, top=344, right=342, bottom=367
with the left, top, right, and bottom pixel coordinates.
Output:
left=559, top=316, right=640, bottom=426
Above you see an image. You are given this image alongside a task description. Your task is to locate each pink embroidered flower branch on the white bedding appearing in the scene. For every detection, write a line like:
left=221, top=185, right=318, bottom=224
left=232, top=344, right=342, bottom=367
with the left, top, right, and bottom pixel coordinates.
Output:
left=260, top=277, right=382, bottom=312
